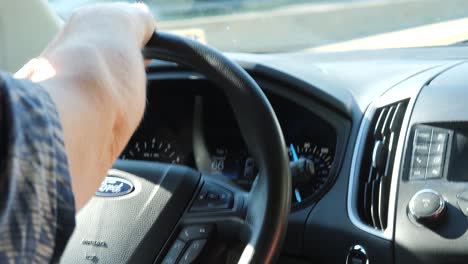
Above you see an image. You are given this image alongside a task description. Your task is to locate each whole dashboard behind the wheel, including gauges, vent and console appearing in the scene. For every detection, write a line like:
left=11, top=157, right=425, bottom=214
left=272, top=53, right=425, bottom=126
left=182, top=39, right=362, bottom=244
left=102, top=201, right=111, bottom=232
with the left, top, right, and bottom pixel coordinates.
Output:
left=121, top=46, right=468, bottom=264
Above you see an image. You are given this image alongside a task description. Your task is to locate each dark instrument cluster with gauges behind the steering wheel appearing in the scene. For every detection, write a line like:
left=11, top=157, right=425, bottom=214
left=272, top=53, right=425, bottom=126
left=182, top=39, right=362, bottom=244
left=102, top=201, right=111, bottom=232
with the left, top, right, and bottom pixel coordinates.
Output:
left=121, top=76, right=337, bottom=205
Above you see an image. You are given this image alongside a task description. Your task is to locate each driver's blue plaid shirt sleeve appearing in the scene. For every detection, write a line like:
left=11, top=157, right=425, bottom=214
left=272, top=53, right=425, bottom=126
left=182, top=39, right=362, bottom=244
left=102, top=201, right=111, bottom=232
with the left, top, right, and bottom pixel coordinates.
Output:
left=0, top=73, right=75, bottom=263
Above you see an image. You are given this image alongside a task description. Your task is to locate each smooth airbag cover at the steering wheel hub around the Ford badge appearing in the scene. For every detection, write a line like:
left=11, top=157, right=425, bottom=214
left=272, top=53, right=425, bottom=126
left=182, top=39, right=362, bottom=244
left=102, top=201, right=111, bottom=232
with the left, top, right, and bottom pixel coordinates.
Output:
left=61, top=160, right=200, bottom=264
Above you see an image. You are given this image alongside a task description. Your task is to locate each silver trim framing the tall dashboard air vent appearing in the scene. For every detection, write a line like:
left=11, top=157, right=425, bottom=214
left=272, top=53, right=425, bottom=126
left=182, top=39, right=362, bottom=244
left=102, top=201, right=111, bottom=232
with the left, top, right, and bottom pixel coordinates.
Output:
left=347, top=62, right=460, bottom=240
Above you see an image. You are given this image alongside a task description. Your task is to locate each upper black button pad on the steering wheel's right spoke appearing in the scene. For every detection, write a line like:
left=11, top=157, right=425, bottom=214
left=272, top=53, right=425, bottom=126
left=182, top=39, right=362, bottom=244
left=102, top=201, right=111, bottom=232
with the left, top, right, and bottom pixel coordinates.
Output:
left=190, top=183, right=233, bottom=212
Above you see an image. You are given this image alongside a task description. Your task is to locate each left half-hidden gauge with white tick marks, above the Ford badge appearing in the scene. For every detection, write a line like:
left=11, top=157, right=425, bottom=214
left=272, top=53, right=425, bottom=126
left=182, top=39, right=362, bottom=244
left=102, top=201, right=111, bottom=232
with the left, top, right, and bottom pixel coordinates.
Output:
left=121, top=138, right=182, bottom=163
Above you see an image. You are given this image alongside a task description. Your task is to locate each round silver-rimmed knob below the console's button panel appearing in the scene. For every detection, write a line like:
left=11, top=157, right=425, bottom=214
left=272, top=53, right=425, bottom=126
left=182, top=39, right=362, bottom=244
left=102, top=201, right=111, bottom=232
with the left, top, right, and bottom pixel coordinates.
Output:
left=408, top=189, right=446, bottom=226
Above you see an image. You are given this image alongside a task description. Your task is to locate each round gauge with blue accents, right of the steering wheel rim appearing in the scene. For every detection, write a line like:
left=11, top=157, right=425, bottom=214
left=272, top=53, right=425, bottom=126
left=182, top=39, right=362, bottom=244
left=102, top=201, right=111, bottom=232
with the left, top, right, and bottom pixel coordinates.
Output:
left=288, top=142, right=333, bottom=203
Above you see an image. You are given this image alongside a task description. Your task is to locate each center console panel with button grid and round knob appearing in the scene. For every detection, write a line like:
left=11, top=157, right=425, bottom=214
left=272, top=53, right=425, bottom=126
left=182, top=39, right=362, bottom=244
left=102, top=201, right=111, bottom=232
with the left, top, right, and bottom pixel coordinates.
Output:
left=394, top=64, right=468, bottom=263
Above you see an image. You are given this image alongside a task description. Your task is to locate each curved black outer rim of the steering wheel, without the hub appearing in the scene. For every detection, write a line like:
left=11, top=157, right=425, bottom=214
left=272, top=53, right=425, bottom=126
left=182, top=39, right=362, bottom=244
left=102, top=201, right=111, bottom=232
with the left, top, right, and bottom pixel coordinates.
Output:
left=144, top=32, right=291, bottom=263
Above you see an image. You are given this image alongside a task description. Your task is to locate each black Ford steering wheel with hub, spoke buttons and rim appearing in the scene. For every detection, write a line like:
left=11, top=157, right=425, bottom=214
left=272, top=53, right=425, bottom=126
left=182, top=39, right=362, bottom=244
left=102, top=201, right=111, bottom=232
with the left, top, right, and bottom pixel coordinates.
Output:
left=61, top=32, right=291, bottom=264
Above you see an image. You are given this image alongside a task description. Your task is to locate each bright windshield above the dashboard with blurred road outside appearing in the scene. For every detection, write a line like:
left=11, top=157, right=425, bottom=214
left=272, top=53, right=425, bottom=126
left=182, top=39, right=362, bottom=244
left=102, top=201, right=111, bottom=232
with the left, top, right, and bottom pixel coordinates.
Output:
left=49, top=0, right=468, bottom=53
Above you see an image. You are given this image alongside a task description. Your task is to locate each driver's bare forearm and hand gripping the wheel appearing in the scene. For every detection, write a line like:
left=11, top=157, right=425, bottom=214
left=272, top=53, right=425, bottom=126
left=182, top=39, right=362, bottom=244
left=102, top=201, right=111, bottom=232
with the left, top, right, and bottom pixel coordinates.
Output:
left=17, top=5, right=154, bottom=208
